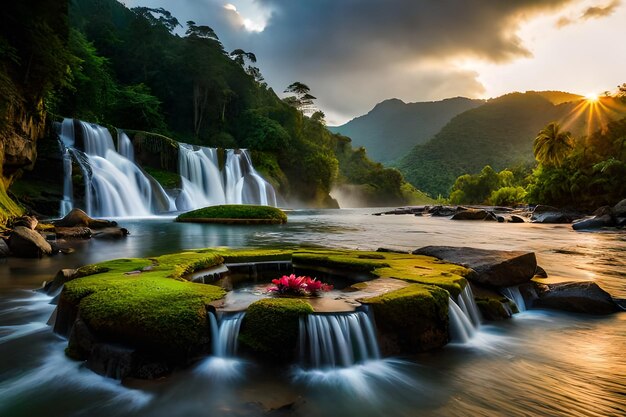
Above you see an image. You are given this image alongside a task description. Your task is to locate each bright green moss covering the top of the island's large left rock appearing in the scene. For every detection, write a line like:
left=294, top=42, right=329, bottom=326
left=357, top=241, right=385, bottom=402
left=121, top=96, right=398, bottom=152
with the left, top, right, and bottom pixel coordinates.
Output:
left=60, top=252, right=224, bottom=356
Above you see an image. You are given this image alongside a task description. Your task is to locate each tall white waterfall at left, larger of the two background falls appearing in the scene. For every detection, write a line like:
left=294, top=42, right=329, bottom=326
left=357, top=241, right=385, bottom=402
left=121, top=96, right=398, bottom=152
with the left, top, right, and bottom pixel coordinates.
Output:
left=59, top=119, right=174, bottom=217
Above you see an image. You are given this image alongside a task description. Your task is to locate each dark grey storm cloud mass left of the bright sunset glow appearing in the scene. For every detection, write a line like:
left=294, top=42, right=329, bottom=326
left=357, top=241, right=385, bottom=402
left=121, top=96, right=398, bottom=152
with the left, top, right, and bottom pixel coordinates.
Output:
left=128, top=0, right=596, bottom=122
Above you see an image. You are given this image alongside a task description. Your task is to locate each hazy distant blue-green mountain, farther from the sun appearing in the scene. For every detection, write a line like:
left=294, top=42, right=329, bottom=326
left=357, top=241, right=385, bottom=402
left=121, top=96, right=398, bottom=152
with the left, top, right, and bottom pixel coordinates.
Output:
left=329, top=97, right=484, bottom=163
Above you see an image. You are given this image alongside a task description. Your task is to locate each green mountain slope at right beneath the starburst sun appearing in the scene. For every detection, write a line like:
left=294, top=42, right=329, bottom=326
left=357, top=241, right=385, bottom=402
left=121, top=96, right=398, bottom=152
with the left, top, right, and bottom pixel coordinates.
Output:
left=397, top=92, right=626, bottom=196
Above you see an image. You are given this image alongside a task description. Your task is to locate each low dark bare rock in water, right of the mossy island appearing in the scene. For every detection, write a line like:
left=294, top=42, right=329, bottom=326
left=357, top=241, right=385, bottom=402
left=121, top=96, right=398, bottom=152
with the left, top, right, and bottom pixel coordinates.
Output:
left=533, top=281, right=620, bottom=315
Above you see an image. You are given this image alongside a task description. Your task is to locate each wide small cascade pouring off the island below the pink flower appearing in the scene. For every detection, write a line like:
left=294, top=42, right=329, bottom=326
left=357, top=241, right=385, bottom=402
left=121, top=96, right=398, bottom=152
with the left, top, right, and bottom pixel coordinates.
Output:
left=299, top=311, right=380, bottom=368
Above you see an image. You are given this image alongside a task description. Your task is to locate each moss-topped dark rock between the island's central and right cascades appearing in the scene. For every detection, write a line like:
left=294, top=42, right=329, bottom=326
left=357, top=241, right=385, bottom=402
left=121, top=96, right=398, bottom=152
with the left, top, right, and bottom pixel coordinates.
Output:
left=361, top=284, right=450, bottom=355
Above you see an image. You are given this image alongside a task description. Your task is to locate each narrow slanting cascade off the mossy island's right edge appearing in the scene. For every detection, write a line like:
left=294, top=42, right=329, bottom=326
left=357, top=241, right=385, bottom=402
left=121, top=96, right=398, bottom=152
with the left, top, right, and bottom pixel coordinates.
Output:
left=448, top=284, right=481, bottom=343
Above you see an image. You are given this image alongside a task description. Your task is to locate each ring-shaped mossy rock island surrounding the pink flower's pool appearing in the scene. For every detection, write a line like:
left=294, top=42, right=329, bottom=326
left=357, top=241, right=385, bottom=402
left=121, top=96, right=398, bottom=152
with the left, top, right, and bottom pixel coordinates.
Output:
left=46, top=247, right=613, bottom=379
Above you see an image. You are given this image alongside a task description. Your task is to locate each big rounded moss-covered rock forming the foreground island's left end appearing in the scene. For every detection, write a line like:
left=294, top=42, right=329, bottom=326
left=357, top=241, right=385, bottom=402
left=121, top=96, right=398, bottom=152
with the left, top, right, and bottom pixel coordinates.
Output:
left=55, top=251, right=225, bottom=377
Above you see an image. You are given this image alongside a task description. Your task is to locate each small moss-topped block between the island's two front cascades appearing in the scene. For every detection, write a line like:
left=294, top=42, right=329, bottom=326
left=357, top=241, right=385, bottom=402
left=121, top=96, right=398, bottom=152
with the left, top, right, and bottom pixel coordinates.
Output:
left=239, top=298, right=313, bottom=362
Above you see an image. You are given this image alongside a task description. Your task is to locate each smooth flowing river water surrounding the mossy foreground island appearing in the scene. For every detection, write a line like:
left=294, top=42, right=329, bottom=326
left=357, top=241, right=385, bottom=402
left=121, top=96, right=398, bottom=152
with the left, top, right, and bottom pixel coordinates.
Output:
left=0, top=209, right=626, bottom=417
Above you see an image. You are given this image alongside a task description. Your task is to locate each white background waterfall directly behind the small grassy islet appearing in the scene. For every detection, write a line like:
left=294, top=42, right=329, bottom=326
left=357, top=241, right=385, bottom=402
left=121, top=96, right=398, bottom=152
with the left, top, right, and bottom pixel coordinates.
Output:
left=176, top=143, right=277, bottom=210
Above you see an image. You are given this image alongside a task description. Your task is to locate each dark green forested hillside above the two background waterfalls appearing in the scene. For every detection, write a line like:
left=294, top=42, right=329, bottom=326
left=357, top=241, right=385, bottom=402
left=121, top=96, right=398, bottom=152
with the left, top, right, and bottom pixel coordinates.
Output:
left=7, top=0, right=419, bottom=207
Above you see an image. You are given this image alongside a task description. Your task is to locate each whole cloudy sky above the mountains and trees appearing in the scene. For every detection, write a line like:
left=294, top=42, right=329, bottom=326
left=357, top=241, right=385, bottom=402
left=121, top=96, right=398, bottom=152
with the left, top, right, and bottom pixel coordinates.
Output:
left=122, top=0, right=626, bottom=125
